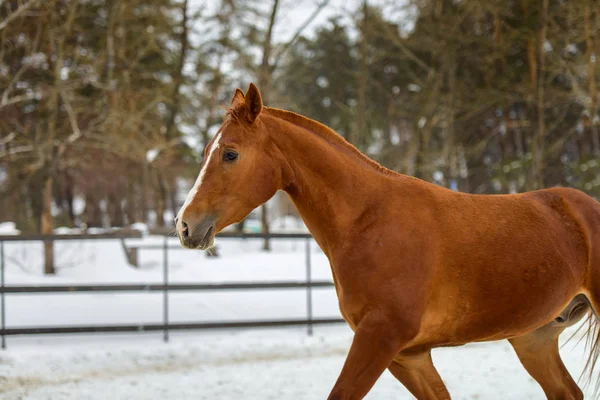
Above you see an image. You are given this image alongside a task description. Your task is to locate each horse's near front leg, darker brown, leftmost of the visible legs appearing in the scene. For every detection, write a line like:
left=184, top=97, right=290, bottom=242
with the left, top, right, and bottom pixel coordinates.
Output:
left=328, top=311, right=416, bottom=400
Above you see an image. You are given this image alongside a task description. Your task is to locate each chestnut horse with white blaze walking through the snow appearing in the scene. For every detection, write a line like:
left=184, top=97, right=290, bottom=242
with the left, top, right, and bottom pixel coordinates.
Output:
left=176, top=84, right=600, bottom=399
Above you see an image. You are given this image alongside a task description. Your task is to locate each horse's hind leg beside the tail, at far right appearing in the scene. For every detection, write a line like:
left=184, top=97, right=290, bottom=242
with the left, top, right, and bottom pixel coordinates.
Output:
left=509, top=296, right=588, bottom=400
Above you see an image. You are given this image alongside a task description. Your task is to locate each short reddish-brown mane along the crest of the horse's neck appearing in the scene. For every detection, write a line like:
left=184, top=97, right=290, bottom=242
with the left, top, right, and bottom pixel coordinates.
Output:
left=262, top=107, right=400, bottom=175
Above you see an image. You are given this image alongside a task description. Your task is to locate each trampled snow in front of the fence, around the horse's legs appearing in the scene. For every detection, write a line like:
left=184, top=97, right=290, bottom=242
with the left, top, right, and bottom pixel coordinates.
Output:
left=0, top=325, right=583, bottom=400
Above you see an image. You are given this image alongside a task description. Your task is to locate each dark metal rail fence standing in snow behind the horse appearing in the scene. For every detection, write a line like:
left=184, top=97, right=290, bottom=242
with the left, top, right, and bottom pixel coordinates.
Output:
left=0, top=231, right=343, bottom=349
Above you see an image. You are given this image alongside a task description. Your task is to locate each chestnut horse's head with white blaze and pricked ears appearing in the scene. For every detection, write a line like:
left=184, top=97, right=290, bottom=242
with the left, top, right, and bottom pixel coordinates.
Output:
left=175, top=84, right=282, bottom=250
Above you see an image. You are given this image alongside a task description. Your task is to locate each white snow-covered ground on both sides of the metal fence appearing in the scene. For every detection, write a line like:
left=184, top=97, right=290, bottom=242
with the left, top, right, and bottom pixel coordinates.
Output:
left=0, top=233, right=591, bottom=400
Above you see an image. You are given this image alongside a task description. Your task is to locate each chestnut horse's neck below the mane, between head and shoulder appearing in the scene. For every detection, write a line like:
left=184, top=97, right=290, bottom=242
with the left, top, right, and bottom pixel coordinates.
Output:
left=266, top=111, right=388, bottom=252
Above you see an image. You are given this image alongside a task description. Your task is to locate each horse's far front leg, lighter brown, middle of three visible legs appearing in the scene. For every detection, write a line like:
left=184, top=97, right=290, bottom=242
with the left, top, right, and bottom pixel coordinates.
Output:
left=388, top=352, right=450, bottom=400
